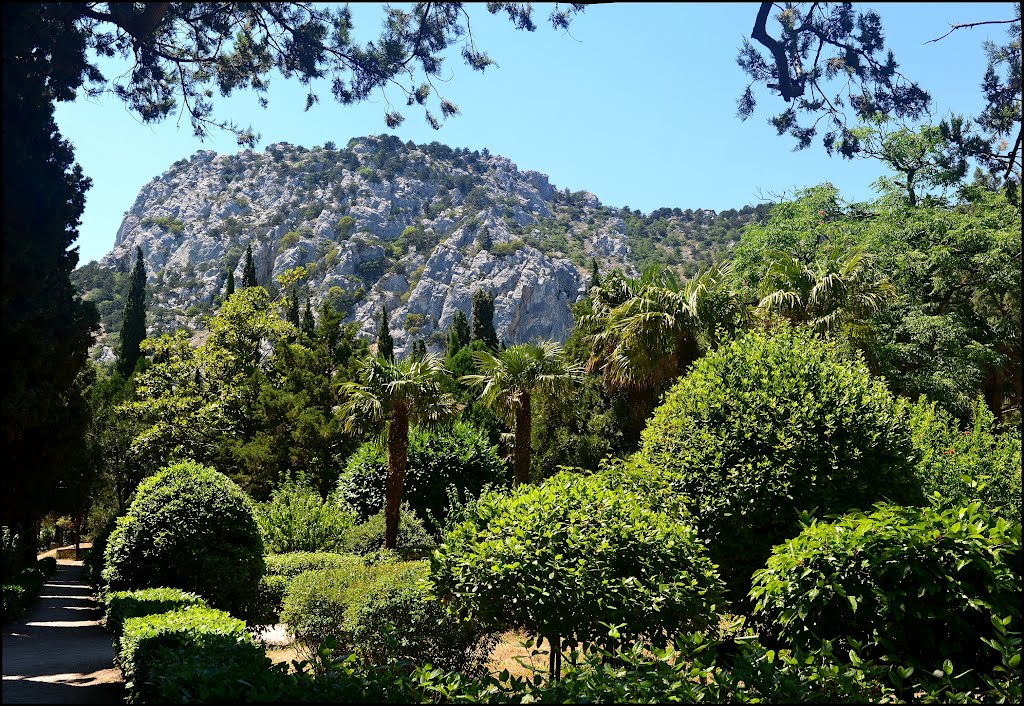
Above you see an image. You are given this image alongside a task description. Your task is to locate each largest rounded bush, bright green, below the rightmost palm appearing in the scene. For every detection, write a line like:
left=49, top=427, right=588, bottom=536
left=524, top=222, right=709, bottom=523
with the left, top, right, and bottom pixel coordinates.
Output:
left=636, top=329, right=921, bottom=598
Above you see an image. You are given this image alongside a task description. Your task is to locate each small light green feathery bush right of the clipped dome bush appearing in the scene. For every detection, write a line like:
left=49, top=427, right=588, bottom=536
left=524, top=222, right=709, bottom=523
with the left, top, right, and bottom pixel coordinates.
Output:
left=256, top=482, right=355, bottom=554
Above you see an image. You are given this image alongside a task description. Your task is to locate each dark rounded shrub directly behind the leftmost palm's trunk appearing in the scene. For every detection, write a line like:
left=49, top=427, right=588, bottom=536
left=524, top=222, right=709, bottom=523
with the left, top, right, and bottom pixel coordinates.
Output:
left=337, top=421, right=509, bottom=532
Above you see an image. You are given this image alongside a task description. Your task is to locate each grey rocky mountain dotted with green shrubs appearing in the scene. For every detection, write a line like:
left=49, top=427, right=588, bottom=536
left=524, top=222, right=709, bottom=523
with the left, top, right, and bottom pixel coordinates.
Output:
left=73, top=135, right=768, bottom=360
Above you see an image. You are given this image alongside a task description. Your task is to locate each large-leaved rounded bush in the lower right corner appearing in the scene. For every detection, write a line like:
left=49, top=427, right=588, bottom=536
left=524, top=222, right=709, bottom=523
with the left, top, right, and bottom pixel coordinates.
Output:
left=751, top=502, right=1021, bottom=673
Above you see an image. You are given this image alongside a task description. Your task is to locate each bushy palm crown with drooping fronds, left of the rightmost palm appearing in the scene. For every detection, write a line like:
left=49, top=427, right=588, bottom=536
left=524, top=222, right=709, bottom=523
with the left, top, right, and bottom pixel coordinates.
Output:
left=580, top=264, right=745, bottom=425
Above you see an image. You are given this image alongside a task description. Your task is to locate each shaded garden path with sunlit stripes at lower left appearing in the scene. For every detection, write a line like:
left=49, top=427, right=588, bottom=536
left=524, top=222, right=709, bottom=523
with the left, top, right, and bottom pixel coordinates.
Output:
left=3, top=560, right=124, bottom=704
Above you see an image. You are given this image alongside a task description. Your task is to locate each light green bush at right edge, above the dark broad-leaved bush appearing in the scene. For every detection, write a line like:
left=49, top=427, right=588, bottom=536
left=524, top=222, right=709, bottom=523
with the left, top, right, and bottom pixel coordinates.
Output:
left=909, top=398, right=1022, bottom=523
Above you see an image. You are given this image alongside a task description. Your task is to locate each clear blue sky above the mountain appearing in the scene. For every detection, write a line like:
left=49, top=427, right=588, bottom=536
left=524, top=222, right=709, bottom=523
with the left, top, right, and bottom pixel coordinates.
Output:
left=56, top=3, right=1013, bottom=263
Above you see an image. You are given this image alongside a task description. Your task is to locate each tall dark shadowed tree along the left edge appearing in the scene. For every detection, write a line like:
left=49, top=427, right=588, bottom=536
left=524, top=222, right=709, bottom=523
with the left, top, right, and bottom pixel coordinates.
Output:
left=0, top=3, right=98, bottom=566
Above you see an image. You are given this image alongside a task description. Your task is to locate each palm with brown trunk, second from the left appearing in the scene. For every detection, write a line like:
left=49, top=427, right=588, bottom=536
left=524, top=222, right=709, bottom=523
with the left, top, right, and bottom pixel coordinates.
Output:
left=460, top=341, right=583, bottom=486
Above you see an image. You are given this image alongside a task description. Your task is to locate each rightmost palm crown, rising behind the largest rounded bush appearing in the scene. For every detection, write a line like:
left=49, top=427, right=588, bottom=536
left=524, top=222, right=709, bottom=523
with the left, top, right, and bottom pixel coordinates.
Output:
left=758, top=246, right=895, bottom=338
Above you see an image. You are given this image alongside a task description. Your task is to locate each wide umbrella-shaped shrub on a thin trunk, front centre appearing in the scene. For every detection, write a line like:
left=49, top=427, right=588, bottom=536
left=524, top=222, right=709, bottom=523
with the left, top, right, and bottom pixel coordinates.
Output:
left=431, top=471, right=722, bottom=668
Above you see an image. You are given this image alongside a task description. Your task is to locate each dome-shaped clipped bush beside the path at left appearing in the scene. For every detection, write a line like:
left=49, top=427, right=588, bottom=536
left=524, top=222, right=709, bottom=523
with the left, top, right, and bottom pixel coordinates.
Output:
left=103, top=461, right=264, bottom=618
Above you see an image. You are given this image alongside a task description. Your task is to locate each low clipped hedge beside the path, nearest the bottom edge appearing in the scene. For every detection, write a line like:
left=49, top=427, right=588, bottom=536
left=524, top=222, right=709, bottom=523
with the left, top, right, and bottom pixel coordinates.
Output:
left=116, top=606, right=262, bottom=703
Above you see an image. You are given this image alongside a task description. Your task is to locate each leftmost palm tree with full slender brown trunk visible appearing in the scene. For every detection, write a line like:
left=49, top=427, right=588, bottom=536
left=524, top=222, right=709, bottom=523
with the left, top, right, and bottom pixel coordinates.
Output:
left=339, top=354, right=458, bottom=549
